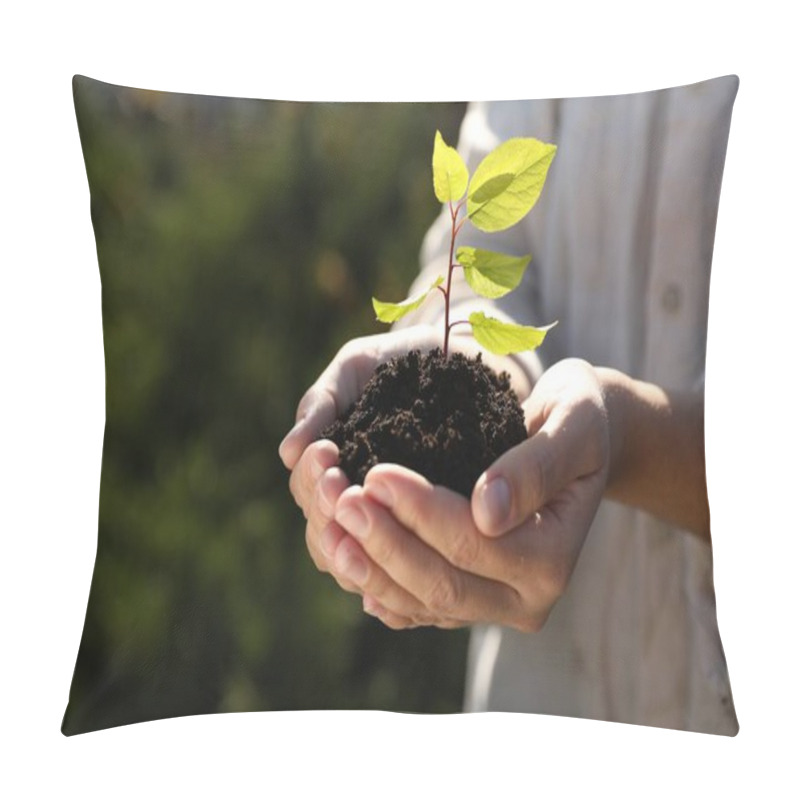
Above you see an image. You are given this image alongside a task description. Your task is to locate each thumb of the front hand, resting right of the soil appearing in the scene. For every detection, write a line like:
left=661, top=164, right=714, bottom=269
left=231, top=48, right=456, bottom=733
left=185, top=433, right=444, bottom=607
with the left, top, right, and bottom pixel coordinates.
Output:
left=471, top=402, right=602, bottom=536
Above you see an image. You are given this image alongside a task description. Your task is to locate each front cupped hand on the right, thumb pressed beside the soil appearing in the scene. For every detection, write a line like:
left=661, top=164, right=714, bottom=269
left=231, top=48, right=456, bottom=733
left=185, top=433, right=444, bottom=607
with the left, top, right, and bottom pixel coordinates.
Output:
left=328, top=360, right=612, bottom=631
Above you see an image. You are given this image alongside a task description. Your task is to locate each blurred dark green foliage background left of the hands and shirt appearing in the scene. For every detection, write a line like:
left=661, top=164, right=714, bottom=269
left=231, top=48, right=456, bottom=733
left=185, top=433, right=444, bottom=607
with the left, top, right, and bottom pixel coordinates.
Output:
left=63, top=77, right=467, bottom=734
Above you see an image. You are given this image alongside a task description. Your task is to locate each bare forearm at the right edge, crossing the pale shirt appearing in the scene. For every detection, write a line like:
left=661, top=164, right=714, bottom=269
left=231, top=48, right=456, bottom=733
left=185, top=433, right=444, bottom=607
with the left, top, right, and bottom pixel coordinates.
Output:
left=597, top=368, right=710, bottom=540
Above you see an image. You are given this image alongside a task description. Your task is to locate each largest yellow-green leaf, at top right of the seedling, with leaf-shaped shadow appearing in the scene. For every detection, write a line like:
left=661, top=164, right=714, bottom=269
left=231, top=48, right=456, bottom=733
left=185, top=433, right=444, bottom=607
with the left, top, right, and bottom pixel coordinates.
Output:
left=467, top=139, right=556, bottom=233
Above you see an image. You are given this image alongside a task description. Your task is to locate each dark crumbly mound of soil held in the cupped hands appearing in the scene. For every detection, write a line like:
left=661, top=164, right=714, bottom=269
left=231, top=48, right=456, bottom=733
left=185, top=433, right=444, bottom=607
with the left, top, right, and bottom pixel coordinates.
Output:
left=321, top=348, right=526, bottom=498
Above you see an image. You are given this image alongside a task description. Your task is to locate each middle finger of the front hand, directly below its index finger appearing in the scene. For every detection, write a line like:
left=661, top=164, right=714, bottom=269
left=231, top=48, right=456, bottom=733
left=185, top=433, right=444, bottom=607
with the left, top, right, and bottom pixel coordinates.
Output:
left=335, top=484, right=518, bottom=624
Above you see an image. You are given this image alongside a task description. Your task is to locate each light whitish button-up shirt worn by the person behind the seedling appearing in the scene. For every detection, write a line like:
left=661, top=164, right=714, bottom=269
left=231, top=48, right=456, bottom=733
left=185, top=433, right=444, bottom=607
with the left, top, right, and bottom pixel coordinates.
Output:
left=409, top=76, right=738, bottom=735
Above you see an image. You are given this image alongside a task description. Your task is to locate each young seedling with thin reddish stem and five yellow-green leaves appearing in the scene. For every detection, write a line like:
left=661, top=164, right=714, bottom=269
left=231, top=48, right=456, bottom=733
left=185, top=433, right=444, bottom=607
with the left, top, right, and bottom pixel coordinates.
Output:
left=372, top=131, right=556, bottom=358
